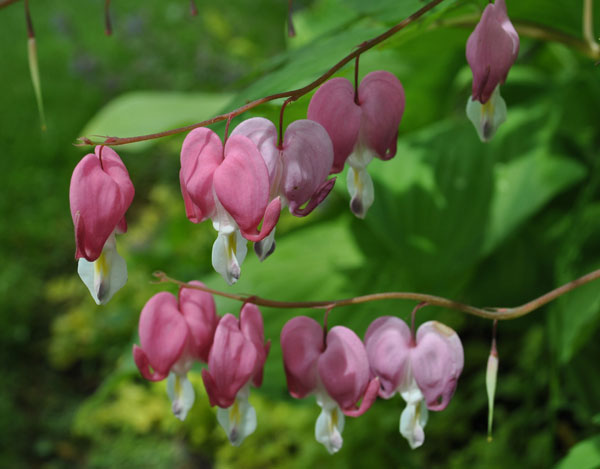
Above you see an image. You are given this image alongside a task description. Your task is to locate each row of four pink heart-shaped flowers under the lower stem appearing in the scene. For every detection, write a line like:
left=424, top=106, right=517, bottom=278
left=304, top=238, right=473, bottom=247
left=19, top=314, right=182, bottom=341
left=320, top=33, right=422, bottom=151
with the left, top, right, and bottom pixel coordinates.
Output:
left=133, top=281, right=463, bottom=453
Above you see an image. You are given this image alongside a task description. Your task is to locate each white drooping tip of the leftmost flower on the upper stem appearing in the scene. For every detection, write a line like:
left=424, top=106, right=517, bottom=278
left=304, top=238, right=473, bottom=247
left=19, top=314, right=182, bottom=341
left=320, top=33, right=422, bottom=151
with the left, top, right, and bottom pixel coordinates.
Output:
left=77, top=233, right=127, bottom=305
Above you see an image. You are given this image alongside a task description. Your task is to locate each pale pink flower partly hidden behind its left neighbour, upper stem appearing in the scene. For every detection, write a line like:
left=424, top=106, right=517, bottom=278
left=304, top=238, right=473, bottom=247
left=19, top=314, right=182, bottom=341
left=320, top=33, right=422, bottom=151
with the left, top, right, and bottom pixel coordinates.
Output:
left=231, top=117, right=335, bottom=260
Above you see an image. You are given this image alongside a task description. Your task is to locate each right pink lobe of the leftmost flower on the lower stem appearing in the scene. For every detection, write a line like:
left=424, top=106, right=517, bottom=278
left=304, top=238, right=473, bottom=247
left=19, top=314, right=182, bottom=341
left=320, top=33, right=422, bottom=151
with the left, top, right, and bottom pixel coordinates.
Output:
left=179, top=280, right=219, bottom=362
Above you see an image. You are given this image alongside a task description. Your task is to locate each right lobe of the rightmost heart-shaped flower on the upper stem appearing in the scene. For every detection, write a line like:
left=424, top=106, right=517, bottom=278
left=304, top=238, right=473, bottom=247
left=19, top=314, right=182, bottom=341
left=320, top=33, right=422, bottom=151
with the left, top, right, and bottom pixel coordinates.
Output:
left=358, top=70, right=405, bottom=160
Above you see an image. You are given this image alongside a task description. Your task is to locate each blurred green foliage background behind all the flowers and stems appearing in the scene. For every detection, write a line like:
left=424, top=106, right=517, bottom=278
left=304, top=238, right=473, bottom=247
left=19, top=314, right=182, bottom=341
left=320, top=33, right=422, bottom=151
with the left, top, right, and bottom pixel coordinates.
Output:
left=0, top=0, right=600, bottom=469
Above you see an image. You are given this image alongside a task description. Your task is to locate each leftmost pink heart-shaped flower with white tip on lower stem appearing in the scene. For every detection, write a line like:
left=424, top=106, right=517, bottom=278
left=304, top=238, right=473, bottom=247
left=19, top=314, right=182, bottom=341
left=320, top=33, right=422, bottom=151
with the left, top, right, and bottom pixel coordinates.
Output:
left=133, top=281, right=219, bottom=420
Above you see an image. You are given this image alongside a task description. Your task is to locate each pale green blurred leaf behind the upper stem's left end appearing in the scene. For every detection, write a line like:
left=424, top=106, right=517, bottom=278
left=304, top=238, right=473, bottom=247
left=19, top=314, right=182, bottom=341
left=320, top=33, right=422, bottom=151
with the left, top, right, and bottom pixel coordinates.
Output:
left=81, top=91, right=231, bottom=152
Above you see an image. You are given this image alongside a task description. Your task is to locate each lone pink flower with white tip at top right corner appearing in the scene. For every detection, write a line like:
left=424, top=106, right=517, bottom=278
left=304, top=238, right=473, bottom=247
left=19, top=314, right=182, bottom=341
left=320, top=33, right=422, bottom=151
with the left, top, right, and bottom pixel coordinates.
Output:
left=467, top=0, right=519, bottom=142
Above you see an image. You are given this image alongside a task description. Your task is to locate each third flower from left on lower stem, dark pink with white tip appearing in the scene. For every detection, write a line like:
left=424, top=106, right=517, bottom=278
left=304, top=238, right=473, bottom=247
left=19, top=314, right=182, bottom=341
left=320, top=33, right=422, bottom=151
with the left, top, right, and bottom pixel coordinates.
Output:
left=281, top=316, right=379, bottom=454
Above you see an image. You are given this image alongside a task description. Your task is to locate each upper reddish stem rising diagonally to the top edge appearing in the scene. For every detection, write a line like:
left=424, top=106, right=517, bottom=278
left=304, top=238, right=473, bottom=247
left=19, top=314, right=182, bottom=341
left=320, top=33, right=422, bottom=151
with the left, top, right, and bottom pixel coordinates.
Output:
left=76, top=0, right=444, bottom=146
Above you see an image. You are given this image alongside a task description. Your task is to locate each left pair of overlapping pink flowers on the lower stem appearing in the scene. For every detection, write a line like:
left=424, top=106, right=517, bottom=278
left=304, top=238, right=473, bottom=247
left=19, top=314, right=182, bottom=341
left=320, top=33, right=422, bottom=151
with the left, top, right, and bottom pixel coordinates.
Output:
left=133, top=281, right=269, bottom=446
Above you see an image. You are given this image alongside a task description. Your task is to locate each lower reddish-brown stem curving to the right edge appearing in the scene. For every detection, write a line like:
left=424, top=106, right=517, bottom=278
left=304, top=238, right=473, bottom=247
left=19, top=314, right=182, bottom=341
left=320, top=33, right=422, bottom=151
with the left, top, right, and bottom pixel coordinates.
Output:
left=154, top=269, right=600, bottom=321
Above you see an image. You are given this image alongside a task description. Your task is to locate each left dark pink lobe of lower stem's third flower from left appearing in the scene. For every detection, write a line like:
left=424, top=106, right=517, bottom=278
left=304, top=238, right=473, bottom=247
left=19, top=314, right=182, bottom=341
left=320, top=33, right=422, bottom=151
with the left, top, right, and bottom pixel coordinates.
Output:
left=280, top=316, right=325, bottom=399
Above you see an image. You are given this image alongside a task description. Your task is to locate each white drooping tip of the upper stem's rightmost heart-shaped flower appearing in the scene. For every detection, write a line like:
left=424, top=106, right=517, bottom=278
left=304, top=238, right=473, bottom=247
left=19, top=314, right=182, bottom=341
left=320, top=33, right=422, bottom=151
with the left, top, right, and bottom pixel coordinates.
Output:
left=346, top=138, right=375, bottom=218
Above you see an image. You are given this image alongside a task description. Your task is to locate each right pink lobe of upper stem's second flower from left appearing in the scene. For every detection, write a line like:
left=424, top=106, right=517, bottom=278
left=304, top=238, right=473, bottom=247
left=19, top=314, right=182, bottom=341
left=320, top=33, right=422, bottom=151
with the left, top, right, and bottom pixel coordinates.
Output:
left=214, top=135, right=270, bottom=241
